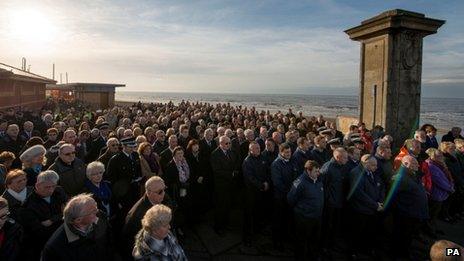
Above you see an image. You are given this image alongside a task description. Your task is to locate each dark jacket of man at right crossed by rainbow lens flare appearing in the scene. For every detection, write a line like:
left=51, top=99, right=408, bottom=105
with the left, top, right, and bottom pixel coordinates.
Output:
left=392, top=166, right=429, bottom=220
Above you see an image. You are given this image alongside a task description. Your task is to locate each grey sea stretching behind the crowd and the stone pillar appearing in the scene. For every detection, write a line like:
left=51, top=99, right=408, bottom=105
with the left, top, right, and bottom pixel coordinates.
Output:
left=115, top=92, right=464, bottom=133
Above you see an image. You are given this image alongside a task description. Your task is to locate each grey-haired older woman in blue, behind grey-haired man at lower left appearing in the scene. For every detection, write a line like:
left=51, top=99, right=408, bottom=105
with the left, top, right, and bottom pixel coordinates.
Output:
left=84, top=161, right=112, bottom=218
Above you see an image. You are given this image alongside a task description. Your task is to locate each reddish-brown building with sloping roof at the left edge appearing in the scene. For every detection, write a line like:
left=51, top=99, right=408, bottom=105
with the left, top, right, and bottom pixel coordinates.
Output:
left=0, top=63, right=56, bottom=110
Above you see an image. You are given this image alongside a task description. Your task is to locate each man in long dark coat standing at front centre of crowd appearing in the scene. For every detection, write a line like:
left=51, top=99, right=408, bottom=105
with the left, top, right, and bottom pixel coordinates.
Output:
left=211, top=136, right=239, bottom=235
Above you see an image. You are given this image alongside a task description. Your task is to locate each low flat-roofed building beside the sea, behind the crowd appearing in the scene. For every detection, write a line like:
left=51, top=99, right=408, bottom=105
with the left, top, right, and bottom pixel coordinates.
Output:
left=47, top=82, right=126, bottom=109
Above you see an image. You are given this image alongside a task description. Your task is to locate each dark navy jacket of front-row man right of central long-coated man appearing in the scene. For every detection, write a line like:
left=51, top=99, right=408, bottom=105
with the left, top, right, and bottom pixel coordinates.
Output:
left=242, top=155, right=270, bottom=190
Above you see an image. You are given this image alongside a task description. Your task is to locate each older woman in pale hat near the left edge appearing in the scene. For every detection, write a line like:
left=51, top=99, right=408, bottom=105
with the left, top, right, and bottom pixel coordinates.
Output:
left=19, top=145, right=47, bottom=186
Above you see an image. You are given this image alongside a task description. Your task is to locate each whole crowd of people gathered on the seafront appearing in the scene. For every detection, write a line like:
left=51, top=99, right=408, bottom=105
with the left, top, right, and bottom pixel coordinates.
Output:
left=0, top=100, right=464, bottom=261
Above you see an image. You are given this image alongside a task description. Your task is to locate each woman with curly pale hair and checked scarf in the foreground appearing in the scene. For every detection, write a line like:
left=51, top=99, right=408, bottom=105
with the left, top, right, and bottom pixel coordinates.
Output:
left=132, top=204, right=187, bottom=261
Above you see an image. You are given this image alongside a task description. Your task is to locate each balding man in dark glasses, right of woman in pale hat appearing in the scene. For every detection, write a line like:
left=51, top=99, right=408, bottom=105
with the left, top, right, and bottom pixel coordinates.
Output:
left=48, top=143, right=86, bottom=197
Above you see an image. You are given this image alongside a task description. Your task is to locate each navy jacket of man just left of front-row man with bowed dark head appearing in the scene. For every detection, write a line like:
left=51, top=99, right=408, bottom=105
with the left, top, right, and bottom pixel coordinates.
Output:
left=271, top=155, right=297, bottom=199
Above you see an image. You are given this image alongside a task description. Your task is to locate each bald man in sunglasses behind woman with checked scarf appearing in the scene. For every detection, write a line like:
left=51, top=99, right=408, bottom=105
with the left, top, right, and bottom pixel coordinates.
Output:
left=122, top=176, right=174, bottom=258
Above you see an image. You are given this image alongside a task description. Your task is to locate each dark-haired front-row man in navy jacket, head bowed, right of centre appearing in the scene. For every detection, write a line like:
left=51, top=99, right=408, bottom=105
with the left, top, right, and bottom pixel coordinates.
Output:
left=287, top=160, right=324, bottom=260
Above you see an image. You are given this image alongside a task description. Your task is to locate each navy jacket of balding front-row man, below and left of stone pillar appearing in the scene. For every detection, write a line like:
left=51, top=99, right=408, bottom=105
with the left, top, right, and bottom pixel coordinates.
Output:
left=348, top=165, right=385, bottom=215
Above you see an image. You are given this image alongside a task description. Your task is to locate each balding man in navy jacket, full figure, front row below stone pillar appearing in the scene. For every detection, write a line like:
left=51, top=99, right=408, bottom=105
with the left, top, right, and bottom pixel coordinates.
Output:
left=348, top=154, right=385, bottom=255
